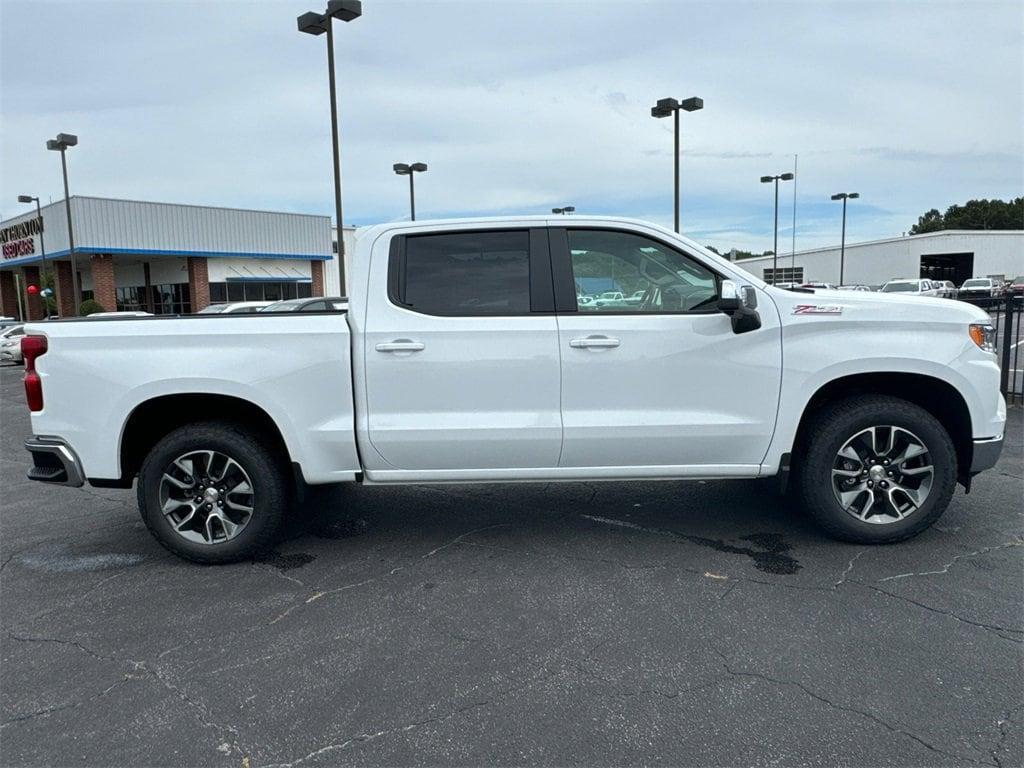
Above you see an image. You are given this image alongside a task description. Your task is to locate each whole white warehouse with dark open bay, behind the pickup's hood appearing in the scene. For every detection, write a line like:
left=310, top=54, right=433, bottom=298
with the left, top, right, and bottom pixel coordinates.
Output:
left=736, top=229, right=1024, bottom=286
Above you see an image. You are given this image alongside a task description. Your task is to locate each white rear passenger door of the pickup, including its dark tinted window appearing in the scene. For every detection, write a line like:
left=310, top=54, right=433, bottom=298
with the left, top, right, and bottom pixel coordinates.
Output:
left=364, top=226, right=562, bottom=477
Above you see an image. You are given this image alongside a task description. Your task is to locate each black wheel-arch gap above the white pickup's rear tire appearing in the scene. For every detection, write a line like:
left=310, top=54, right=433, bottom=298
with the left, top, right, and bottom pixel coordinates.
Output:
left=115, top=392, right=291, bottom=487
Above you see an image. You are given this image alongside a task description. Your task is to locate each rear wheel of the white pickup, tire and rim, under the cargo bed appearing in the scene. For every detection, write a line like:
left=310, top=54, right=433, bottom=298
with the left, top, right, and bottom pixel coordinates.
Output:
left=137, top=422, right=289, bottom=563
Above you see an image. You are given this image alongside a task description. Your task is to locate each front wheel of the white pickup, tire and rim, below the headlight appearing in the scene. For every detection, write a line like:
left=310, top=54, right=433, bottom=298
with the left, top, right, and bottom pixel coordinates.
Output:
left=797, top=395, right=956, bottom=544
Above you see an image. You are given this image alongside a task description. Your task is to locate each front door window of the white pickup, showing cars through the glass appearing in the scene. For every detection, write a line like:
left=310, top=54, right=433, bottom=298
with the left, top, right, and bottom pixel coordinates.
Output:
left=567, top=229, right=719, bottom=312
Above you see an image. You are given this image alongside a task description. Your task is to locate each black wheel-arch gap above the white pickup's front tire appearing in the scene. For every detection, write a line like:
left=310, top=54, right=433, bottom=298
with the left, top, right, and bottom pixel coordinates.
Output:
left=793, top=372, right=974, bottom=482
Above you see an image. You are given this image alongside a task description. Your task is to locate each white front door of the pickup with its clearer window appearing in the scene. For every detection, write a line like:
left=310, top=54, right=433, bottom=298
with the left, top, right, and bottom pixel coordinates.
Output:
left=551, top=227, right=781, bottom=475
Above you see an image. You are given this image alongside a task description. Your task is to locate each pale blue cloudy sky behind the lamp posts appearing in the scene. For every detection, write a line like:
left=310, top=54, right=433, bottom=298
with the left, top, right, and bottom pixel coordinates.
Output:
left=0, top=0, right=1024, bottom=253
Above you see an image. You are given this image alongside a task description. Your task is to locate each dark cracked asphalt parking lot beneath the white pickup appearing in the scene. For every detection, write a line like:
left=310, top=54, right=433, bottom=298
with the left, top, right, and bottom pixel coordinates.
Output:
left=0, top=367, right=1024, bottom=767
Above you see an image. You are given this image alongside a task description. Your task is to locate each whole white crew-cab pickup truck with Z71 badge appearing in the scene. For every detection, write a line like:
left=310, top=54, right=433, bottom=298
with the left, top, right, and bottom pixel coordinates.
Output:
left=24, top=216, right=1006, bottom=562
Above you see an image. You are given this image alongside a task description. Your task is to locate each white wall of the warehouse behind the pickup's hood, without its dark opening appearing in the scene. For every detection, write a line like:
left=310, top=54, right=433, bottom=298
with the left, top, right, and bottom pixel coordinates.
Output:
left=735, top=230, right=1024, bottom=285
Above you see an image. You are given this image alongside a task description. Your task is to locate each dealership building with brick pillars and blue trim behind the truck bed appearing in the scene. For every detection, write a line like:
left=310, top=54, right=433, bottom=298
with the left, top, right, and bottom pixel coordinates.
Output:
left=0, top=196, right=354, bottom=319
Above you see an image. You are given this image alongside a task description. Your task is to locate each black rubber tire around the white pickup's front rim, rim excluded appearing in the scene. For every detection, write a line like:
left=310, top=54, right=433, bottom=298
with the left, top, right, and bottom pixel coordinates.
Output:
left=795, top=395, right=957, bottom=544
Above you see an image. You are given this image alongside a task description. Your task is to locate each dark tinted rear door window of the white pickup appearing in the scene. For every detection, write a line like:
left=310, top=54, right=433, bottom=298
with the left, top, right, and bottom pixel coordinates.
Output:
left=391, top=229, right=530, bottom=316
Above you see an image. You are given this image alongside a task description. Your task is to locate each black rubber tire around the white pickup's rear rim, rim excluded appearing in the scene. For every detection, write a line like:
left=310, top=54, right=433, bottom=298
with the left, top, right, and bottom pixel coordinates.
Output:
left=136, top=421, right=291, bottom=564
